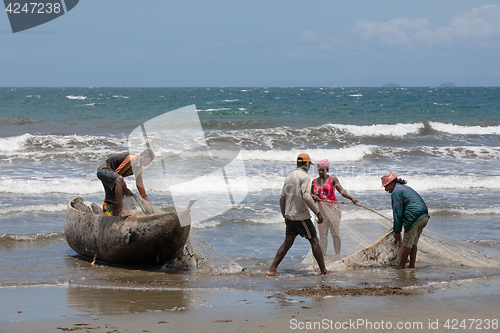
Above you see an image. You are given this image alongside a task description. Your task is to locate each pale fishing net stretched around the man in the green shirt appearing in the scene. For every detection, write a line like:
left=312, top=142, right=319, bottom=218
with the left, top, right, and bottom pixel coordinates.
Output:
left=302, top=202, right=500, bottom=270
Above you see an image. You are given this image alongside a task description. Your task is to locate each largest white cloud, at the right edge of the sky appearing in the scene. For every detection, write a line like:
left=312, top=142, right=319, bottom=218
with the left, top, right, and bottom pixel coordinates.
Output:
left=352, top=5, right=500, bottom=48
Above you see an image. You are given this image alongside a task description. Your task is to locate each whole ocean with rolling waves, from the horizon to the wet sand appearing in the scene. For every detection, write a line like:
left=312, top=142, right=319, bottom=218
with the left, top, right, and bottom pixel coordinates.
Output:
left=0, top=87, right=500, bottom=321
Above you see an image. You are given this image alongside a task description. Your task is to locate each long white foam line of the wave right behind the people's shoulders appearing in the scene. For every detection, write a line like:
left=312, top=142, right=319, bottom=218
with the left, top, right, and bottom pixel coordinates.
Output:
left=0, top=173, right=500, bottom=195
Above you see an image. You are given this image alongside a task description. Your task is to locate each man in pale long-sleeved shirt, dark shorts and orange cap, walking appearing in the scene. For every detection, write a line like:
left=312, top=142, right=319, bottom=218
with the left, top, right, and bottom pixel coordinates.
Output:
left=266, top=154, right=332, bottom=276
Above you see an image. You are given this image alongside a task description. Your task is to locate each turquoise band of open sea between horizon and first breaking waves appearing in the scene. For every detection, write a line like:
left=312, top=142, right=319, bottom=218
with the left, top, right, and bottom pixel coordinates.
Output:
left=0, top=87, right=500, bottom=137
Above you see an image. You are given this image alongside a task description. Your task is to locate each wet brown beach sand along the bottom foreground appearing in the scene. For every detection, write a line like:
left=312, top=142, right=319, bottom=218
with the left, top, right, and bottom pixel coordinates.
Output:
left=4, top=277, right=500, bottom=333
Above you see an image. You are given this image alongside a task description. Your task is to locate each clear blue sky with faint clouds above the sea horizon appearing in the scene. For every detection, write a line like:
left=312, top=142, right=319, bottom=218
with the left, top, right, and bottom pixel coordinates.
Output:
left=0, top=0, right=500, bottom=87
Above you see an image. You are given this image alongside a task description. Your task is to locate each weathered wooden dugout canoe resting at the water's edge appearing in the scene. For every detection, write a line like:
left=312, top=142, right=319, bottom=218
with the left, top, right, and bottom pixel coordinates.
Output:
left=64, top=197, right=191, bottom=266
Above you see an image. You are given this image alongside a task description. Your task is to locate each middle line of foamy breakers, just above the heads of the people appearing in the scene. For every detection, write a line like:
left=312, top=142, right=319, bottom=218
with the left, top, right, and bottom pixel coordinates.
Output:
left=0, top=131, right=500, bottom=162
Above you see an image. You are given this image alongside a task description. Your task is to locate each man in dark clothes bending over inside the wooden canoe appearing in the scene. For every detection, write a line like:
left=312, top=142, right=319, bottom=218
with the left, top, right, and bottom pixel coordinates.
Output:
left=97, top=149, right=155, bottom=217
